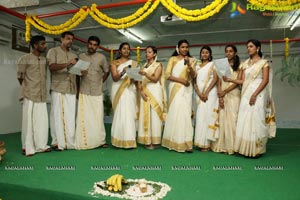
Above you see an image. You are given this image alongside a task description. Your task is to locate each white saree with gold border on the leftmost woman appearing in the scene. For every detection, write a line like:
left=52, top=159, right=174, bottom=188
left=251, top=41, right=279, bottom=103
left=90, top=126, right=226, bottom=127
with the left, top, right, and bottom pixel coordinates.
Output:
left=111, top=60, right=137, bottom=148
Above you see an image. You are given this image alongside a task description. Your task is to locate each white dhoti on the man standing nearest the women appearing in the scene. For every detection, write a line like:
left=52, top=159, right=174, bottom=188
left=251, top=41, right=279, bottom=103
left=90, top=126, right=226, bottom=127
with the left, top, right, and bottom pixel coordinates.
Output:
left=75, top=94, right=106, bottom=149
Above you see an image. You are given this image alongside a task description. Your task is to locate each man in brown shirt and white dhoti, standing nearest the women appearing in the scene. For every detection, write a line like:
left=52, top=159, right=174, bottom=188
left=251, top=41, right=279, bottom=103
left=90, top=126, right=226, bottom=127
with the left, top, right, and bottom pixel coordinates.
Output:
left=75, top=36, right=109, bottom=149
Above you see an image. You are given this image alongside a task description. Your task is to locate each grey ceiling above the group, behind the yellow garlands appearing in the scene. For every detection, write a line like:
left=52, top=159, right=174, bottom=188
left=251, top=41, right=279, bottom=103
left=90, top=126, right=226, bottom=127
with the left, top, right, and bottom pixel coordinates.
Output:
left=0, top=0, right=300, bottom=48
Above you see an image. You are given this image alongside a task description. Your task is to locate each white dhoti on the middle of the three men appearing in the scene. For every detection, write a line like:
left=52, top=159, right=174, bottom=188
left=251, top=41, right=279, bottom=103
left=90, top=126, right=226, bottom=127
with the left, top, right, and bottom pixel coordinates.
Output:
left=50, top=91, right=76, bottom=150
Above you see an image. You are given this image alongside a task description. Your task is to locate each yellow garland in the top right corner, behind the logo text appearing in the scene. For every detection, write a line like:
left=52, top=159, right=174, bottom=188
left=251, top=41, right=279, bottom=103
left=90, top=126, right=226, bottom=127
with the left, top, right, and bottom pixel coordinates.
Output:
left=248, top=0, right=300, bottom=12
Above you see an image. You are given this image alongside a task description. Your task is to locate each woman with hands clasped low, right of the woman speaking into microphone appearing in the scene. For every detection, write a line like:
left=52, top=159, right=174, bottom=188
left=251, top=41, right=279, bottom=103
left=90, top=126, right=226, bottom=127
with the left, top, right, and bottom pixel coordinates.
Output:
left=194, top=46, right=219, bottom=151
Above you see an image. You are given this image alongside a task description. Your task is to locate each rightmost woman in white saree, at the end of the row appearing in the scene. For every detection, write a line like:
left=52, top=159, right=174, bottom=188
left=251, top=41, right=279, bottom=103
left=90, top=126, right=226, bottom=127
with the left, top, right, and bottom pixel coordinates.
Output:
left=223, top=39, right=276, bottom=157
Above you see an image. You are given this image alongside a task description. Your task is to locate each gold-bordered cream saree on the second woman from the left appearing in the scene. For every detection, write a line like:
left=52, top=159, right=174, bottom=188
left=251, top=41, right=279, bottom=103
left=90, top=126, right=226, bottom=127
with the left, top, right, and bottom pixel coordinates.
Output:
left=138, top=62, right=166, bottom=145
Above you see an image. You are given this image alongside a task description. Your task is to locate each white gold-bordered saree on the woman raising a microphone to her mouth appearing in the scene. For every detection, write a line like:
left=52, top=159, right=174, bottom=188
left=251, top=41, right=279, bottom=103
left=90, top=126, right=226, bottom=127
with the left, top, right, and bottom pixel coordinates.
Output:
left=162, top=59, right=193, bottom=152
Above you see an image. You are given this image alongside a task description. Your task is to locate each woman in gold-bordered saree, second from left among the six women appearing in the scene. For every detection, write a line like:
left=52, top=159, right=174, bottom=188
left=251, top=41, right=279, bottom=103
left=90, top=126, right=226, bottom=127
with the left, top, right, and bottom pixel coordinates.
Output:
left=138, top=46, right=166, bottom=149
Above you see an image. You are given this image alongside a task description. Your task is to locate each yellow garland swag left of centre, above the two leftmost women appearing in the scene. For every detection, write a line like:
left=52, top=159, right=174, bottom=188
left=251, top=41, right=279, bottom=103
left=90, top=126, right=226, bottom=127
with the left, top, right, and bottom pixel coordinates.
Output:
left=89, top=0, right=160, bottom=29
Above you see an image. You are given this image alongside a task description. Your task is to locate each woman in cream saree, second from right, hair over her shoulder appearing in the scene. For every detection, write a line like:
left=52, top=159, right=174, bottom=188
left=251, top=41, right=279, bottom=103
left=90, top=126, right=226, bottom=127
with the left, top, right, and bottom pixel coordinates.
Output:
left=212, top=44, right=241, bottom=154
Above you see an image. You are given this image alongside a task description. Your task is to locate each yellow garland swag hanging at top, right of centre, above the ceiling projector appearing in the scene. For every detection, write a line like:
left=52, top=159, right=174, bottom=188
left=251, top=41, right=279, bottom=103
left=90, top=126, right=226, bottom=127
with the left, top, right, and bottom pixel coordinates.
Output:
left=161, top=0, right=229, bottom=21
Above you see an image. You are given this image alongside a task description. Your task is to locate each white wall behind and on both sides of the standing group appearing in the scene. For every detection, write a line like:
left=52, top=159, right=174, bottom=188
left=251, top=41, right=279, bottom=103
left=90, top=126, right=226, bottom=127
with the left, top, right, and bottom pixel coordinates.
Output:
left=0, top=38, right=300, bottom=134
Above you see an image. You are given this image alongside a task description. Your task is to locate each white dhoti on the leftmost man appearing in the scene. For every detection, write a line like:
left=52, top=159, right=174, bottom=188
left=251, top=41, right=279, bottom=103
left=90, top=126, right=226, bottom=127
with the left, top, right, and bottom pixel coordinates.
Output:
left=21, top=98, right=49, bottom=155
